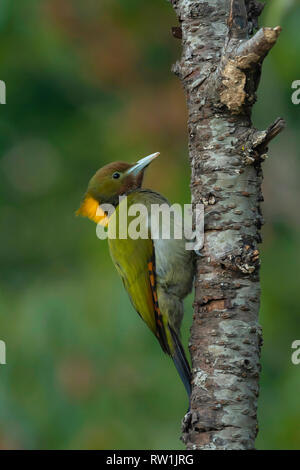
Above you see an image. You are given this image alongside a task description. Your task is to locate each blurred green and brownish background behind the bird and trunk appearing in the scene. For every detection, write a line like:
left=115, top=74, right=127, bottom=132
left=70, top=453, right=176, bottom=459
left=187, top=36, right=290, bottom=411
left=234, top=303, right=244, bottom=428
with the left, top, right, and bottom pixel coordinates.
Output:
left=0, top=0, right=300, bottom=449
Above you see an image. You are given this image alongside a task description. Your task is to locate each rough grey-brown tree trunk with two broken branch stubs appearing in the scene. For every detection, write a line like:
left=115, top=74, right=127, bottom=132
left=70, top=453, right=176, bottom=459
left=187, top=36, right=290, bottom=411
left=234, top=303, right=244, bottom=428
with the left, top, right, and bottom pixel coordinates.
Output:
left=171, top=0, right=284, bottom=449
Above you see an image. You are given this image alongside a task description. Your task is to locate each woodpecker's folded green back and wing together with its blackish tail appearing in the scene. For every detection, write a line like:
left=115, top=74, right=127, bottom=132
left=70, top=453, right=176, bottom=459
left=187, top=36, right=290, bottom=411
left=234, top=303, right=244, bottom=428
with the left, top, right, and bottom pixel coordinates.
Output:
left=108, top=191, right=191, bottom=396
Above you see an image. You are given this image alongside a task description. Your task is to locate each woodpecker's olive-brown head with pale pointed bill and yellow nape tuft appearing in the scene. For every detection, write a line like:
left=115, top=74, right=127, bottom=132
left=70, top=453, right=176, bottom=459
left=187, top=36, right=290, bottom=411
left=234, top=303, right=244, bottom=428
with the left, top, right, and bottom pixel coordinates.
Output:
left=76, top=152, right=159, bottom=225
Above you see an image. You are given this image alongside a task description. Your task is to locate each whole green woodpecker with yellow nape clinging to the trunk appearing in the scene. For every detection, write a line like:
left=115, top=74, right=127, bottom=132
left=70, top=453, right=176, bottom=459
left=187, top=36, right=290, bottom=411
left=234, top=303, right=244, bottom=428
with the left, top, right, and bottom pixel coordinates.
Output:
left=76, top=153, right=194, bottom=396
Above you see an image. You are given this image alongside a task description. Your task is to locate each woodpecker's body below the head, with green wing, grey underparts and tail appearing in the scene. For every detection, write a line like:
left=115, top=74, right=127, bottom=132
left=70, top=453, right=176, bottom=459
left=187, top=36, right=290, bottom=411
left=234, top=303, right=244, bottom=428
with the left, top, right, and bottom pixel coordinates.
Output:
left=108, top=190, right=194, bottom=393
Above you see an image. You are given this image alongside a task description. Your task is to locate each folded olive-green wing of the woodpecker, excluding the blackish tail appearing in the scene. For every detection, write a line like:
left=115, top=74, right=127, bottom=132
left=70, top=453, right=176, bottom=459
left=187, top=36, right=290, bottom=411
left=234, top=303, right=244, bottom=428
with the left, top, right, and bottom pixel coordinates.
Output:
left=108, top=199, right=172, bottom=354
